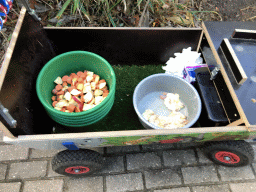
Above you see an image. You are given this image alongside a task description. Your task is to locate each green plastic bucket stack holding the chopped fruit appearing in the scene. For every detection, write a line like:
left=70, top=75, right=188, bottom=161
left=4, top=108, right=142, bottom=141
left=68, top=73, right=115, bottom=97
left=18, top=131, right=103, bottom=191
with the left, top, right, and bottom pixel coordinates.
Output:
left=36, top=51, right=116, bottom=127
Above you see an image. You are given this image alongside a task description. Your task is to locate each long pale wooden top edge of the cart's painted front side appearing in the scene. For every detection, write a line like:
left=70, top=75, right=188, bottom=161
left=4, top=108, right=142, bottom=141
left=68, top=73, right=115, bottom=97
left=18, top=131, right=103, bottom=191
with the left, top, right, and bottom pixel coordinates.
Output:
left=4, top=126, right=248, bottom=141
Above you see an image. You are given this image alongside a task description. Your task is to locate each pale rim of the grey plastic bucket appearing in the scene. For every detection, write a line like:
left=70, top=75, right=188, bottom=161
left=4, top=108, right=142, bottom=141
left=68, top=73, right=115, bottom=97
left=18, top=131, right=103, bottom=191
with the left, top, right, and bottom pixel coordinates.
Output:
left=133, top=73, right=202, bottom=129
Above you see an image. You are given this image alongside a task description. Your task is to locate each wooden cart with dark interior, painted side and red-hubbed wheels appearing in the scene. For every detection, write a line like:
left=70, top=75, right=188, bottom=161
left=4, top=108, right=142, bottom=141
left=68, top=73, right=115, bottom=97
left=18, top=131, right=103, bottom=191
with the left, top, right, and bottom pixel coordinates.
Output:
left=0, top=7, right=256, bottom=176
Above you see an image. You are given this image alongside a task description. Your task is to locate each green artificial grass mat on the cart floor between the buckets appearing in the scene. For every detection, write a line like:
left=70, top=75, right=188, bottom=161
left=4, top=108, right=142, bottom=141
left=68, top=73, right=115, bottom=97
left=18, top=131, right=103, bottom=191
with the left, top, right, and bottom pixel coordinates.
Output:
left=55, top=64, right=165, bottom=133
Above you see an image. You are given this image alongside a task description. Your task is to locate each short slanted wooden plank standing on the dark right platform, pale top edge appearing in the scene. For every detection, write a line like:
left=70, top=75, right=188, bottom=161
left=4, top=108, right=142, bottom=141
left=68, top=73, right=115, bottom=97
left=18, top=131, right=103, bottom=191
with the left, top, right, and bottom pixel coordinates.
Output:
left=220, top=38, right=247, bottom=85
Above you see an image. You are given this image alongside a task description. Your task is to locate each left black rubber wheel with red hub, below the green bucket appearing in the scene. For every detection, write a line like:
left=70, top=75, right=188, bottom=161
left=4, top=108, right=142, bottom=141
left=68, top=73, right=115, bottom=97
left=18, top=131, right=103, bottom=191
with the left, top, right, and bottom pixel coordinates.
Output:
left=52, top=149, right=104, bottom=177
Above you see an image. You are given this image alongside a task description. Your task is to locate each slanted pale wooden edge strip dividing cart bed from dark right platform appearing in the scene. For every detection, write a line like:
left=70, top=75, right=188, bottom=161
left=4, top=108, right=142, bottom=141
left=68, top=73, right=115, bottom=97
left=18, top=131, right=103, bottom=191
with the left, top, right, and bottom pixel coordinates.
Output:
left=202, top=22, right=250, bottom=127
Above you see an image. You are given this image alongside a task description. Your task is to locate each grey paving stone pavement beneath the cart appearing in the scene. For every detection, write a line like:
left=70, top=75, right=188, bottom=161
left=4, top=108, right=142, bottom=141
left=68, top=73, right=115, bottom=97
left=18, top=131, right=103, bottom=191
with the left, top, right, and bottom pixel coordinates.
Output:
left=0, top=136, right=256, bottom=192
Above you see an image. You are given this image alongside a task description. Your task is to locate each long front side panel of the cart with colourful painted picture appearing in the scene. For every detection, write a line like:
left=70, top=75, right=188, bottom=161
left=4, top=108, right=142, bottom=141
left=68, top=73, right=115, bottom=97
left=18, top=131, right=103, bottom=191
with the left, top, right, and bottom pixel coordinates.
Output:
left=4, top=126, right=252, bottom=150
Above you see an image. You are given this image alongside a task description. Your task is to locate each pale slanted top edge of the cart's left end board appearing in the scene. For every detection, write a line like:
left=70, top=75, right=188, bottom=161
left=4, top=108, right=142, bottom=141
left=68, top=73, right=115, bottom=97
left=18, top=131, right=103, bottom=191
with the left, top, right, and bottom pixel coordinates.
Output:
left=0, top=7, right=26, bottom=90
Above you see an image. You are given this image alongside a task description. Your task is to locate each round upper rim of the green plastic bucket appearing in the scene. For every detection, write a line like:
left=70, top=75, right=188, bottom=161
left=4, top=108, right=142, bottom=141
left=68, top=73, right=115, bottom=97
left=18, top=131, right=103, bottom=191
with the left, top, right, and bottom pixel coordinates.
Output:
left=36, top=51, right=116, bottom=117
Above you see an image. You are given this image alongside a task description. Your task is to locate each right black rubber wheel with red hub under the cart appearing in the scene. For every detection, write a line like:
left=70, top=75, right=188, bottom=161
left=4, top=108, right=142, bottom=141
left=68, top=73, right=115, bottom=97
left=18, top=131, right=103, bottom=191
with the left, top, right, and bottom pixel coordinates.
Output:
left=203, top=140, right=254, bottom=167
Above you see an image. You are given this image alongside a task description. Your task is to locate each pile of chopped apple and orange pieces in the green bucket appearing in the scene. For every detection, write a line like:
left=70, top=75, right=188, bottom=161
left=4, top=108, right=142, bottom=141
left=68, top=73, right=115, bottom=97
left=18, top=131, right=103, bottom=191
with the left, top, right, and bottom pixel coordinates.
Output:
left=52, top=70, right=109, bottom=113
